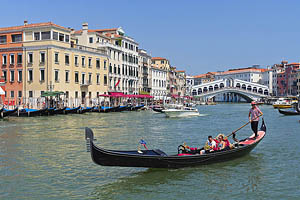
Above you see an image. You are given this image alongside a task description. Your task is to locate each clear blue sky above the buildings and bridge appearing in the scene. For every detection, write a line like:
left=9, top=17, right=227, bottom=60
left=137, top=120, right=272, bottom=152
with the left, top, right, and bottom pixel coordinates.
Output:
left=0, top=0, right=300, bottom=75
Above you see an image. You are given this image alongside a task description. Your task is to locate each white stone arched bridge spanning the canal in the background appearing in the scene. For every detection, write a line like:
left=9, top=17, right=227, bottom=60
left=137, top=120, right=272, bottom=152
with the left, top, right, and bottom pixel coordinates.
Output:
left=192, top=78, right=269, bottom=102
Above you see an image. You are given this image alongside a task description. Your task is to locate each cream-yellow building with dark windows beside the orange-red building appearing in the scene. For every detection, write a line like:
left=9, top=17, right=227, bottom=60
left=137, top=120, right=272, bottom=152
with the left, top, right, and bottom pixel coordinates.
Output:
left=0, top=22, right=108, bottom=106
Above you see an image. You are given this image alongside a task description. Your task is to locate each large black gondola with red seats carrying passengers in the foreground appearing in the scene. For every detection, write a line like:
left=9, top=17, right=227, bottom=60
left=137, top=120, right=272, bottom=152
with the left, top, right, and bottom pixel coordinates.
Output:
left=85, top=121, right=266, bottom=168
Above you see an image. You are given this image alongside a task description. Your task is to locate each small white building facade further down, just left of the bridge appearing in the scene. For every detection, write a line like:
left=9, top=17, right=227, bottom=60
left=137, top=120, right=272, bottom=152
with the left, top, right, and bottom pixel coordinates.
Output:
left=151, top=66, right=167, bottom=100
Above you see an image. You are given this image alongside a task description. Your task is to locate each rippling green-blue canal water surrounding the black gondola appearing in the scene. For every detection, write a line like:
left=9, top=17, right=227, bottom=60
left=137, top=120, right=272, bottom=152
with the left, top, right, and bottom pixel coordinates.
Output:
left=0, top=104, right=300, bottom=200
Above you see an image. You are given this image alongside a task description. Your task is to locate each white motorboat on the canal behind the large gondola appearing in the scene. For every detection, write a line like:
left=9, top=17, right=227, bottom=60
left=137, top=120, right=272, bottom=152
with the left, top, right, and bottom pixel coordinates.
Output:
left=162, top=106, right=200, bottom=117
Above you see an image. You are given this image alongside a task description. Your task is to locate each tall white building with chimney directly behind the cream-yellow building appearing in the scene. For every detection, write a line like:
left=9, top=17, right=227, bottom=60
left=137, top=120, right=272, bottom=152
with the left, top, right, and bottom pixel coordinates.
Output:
left=73, top=23, right=139, bottom=94
